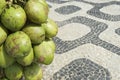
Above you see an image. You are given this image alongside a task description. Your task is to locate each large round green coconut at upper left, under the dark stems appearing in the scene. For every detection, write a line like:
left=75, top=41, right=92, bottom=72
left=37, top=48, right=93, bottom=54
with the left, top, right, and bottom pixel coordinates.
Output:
left=1, top=5, right=26, bottom=32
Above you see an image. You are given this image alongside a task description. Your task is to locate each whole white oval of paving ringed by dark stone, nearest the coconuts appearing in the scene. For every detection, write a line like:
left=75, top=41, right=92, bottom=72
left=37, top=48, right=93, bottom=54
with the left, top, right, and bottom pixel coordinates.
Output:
left=57, top=23, right=90, bottom=40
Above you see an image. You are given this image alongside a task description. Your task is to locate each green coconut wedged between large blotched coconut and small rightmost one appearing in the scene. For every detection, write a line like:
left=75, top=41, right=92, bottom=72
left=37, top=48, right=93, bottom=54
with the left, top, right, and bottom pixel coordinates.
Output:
left=22, top=24, right=45, bottom=44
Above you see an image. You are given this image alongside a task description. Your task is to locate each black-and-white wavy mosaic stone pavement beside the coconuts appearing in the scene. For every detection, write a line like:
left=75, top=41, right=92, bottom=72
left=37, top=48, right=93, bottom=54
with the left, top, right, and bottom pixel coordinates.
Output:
left=43, top=0, right=120, bottom=80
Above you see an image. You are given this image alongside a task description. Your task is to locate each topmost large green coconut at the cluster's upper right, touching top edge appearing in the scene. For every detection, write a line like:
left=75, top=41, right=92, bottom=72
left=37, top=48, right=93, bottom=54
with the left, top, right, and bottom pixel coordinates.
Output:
left=24, top=0, right=49, bottom=24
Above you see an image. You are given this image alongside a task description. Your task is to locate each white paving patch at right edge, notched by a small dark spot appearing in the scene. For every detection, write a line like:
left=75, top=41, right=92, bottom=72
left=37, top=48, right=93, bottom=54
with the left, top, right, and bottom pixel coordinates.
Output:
left=99, top=22, right=120, bottom=47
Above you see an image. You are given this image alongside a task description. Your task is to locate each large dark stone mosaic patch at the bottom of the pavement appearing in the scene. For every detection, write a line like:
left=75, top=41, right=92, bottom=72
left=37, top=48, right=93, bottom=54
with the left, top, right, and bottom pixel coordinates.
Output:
left=53, top=58, right=111, bottom=80
